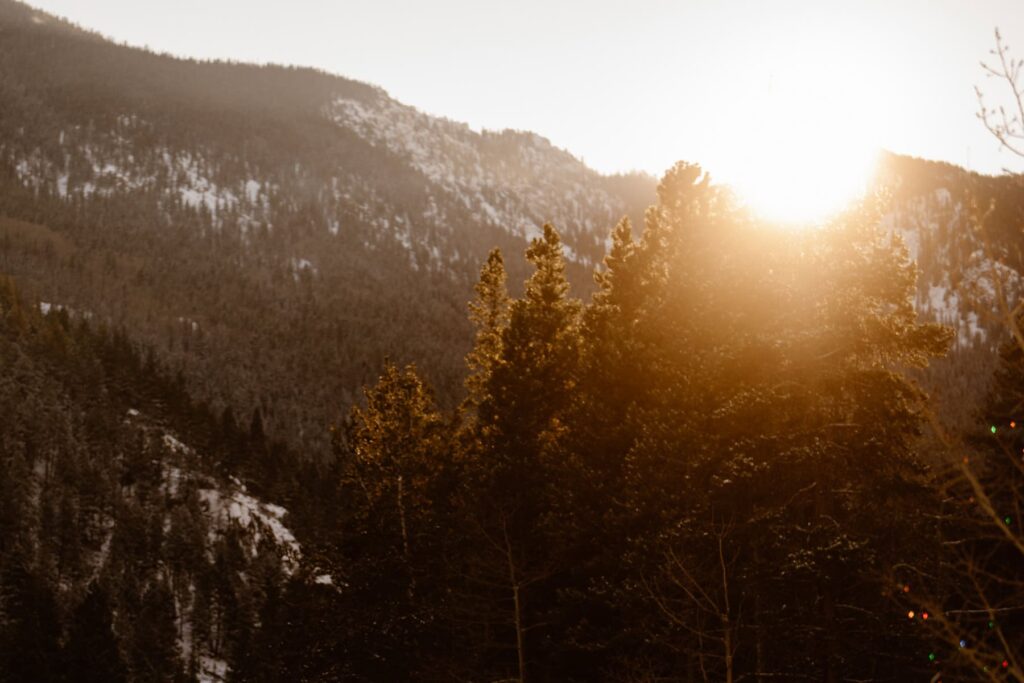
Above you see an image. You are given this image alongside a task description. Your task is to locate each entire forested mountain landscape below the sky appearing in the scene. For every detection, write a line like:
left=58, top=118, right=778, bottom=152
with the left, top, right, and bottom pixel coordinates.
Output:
left=0, top=0, right=1024, bottom=683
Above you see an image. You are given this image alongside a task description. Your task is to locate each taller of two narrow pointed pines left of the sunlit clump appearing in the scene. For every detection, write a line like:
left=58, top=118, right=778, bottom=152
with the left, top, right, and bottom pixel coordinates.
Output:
left=465, top=225, right=581, bottom=681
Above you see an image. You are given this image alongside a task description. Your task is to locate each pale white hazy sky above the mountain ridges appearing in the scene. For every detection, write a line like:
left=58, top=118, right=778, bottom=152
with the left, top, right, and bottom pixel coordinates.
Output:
left=19, top=0, right=1024, bottom=176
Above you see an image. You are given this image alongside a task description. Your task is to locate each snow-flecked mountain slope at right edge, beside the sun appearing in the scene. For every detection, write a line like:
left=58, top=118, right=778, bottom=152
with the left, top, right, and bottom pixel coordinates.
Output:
left=878, top=155, right=1024, bottom=428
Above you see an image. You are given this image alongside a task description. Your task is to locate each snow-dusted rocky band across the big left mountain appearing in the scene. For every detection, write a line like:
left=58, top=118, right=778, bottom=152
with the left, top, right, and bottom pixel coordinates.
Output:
left=0, top=100, right=634, bottom=269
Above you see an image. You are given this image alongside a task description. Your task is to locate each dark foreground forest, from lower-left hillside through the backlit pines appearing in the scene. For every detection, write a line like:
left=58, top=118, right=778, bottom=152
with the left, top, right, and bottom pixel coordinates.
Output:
left=2, top=158, right=1022, bottom=681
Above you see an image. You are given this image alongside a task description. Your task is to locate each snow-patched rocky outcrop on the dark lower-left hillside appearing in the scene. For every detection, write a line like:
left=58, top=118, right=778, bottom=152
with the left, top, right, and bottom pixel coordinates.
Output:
left=117, top=410, right=321, bottom=683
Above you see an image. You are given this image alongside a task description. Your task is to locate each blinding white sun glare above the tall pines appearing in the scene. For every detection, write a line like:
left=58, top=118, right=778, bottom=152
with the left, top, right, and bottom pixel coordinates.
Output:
left=709, top=65, right=879, bottom=227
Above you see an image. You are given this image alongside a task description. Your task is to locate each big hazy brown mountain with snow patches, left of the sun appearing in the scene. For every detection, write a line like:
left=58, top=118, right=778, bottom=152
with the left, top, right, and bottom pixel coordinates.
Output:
left=0, top=0, right=654, bottom=454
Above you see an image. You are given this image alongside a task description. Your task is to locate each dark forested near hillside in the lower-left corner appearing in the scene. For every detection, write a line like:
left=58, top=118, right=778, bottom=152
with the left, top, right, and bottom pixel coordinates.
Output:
left=0, top=279, right=344, bottom=682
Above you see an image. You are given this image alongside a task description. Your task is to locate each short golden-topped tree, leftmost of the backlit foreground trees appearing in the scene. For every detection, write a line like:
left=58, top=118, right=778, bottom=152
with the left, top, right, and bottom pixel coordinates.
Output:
left=341, top=362, right=456, bottom=679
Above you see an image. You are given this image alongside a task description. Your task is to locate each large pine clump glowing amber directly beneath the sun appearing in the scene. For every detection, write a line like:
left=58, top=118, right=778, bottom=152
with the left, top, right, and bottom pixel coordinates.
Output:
left=544, top=165, right=948, bottom=680
